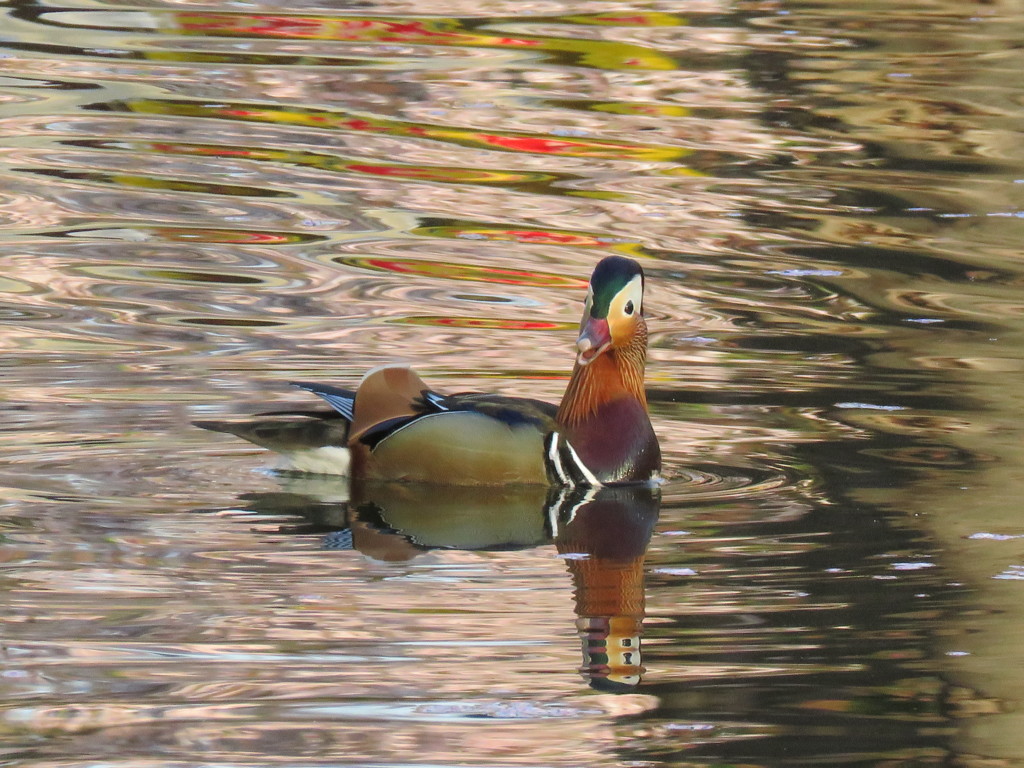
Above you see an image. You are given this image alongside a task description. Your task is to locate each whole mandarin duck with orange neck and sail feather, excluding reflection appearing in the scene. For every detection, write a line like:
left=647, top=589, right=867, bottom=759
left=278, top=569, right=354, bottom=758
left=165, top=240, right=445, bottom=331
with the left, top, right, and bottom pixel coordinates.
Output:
left=195, top=256, right=662, bottom=486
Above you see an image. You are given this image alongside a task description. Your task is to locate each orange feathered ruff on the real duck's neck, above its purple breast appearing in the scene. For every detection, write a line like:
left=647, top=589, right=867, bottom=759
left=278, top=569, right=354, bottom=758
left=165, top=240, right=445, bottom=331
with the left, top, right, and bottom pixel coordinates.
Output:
left=556, top=317, right=647, bottom=427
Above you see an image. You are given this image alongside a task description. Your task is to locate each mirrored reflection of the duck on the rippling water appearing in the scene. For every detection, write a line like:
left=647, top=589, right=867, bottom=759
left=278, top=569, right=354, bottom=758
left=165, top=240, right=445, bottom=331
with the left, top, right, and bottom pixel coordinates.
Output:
left=218, top=475, right=660, bottom=693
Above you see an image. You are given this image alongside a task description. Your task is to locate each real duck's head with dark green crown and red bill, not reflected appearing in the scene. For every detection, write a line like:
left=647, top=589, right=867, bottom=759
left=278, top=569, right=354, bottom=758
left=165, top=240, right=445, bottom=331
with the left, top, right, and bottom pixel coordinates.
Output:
left=577, top=256, right=643, bottom=366
